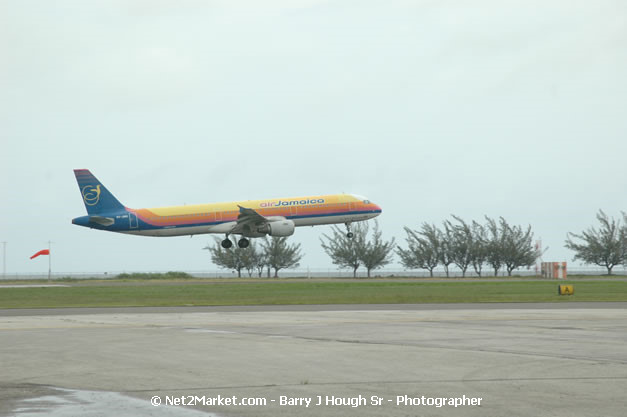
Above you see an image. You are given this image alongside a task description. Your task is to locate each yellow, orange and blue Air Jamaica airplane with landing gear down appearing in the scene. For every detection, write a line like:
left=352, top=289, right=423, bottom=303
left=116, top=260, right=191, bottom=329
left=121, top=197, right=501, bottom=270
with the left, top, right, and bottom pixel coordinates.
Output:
left=72, top=169, right=381, bottom=249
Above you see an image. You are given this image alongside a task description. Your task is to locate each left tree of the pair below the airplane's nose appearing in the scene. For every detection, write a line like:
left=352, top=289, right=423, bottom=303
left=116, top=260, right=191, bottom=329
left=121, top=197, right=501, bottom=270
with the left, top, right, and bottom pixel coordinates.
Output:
left=320, top=223, right=368, bottom=278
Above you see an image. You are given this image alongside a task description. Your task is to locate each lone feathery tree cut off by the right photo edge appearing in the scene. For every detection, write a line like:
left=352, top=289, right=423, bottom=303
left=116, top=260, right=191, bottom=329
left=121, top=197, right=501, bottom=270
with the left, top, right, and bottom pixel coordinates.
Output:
left=565, top=210, right=627, bottom=275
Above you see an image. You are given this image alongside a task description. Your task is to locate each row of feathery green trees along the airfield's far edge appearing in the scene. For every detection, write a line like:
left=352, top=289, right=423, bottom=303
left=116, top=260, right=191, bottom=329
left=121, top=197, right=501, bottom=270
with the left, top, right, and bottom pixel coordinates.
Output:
left=204, top=211, right=627, bottom=277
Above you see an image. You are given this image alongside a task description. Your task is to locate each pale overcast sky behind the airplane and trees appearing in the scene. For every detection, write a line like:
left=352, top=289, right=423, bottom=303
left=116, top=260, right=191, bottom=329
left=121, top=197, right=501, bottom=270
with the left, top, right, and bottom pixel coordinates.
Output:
left=0, top=0, right=627, bottom=273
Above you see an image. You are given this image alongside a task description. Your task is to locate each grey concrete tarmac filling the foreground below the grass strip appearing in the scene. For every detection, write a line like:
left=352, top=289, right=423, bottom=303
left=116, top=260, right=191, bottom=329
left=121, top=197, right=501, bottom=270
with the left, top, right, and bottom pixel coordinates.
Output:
left=0, top=303, right=627, bottom=417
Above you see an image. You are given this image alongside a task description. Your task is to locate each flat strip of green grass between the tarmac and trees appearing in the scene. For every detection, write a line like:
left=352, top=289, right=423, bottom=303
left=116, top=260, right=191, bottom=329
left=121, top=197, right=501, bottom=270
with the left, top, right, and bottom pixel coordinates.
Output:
left=0, top=280, right=627, bottom=308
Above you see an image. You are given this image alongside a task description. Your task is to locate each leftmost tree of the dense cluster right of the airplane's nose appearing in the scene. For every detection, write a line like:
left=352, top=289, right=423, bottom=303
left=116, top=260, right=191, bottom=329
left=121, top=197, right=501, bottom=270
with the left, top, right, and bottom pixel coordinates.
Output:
left=396, top=223, right=440, bottom=277
